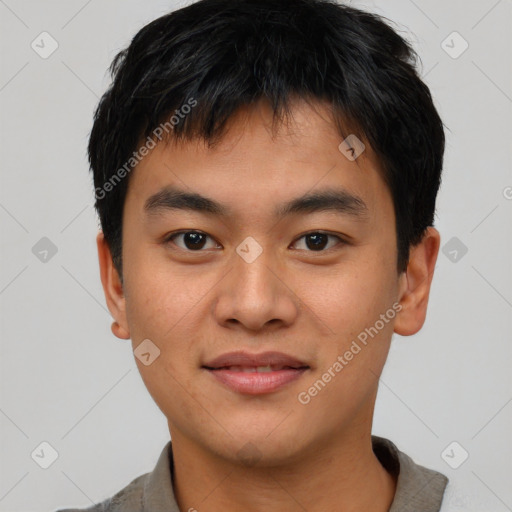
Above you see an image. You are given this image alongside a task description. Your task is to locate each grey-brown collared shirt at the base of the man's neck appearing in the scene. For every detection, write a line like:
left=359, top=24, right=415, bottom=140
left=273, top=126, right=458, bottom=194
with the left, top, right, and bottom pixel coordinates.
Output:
left=57, top=436, right=448, bottom=512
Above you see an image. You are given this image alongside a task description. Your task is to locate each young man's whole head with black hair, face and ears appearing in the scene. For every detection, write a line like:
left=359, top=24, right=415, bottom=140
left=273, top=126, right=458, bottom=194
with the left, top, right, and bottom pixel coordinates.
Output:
left=89, top=0, right=444, bottom=464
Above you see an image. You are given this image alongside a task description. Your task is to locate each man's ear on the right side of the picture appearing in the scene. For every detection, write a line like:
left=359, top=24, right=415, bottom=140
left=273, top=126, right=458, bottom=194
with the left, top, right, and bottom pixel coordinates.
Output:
left=395, top=227, right=441, bottom=336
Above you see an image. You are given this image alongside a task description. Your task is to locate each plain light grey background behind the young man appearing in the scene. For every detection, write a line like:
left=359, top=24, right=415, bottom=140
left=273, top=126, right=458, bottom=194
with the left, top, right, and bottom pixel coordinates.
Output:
left=0, top=0, right=512, bottom=512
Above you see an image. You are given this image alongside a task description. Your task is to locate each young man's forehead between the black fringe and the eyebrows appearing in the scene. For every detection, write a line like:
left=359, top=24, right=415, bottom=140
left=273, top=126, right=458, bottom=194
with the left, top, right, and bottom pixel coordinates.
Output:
left=125, top=98, right=391, bottom=222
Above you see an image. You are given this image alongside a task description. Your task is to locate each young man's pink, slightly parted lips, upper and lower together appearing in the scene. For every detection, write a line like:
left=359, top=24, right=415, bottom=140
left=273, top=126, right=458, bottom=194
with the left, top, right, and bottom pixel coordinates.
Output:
left=202, top=352, right=309, bottom=395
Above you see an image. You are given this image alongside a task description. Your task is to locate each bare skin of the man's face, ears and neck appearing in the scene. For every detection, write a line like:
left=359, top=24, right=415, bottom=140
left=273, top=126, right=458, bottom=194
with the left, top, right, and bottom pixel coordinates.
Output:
left=97, top=100, right=440, bottom=512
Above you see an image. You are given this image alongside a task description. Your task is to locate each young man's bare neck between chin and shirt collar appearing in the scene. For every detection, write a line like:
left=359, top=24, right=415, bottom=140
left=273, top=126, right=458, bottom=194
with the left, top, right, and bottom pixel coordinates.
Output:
left=172, top=431, right=396, bottom=512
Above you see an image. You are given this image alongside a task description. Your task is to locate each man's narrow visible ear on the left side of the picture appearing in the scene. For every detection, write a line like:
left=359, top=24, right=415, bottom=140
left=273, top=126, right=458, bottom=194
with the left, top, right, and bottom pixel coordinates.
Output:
left=96, top=231, right=130, bottom=340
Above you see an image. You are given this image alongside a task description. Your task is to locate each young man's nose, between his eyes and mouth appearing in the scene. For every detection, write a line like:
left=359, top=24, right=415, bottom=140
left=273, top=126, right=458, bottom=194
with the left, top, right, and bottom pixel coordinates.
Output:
left=214, top=243, right=300, bottom=331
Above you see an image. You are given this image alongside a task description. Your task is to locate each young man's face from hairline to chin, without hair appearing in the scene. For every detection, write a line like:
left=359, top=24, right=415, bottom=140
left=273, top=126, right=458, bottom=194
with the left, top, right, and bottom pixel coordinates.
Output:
left=102, top=98, right=436, bottom=464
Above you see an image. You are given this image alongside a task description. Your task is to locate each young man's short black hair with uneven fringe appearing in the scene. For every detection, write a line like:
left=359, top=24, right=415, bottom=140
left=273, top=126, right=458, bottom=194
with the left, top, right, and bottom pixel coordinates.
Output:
left=88, top=0, right=445, bottom=278
